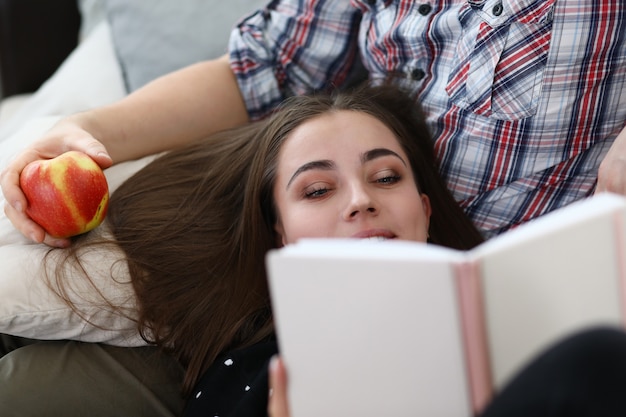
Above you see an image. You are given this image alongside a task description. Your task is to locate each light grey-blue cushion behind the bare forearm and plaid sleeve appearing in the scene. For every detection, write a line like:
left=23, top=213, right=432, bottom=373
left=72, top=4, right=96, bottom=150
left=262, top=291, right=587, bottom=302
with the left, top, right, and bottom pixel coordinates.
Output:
left=105, top=0, right=267, bottom=91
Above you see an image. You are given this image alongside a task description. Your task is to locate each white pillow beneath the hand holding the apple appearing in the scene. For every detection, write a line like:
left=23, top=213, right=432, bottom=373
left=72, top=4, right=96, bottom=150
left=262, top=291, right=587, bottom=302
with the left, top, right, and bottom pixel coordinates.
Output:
left=0, top=117, right=152, bottom=346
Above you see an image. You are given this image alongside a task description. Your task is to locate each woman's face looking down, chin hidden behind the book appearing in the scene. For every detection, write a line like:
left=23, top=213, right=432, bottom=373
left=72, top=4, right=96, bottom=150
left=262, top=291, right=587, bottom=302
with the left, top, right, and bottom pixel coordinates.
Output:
left=274, top=111, right=431, bottom=245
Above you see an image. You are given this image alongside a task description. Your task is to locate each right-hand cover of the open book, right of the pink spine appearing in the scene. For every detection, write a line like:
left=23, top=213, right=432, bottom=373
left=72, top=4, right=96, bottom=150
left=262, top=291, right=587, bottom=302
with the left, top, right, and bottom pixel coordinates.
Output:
left=474, top=195, right=626, bottom=387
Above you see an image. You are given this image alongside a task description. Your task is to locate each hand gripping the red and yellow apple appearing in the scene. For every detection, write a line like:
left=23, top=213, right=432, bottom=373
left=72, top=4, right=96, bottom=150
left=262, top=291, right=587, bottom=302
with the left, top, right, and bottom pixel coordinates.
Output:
left=0, top=120, right=113, bottom=247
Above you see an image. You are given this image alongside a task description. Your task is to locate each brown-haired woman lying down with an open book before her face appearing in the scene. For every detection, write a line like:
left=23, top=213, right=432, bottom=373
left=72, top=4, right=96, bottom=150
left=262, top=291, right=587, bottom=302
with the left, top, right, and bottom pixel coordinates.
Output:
left=0, top=82, right=482, bottom=415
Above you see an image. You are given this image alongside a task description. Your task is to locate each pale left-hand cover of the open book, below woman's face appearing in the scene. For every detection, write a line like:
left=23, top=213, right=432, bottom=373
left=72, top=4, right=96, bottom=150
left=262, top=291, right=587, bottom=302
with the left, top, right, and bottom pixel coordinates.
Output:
left=268, top=241, right=472, bottom=417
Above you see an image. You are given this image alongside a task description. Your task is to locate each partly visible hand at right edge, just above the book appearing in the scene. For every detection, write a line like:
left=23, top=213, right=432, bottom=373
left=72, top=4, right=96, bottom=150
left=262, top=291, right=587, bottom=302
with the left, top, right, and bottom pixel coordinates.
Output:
left=596, top=123, right=626, bottom=195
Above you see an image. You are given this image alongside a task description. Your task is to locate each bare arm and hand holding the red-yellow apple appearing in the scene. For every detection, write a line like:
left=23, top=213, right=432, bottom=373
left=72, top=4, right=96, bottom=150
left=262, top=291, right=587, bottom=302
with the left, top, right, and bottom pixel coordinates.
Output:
left=0, top=56, right=248, bottom=246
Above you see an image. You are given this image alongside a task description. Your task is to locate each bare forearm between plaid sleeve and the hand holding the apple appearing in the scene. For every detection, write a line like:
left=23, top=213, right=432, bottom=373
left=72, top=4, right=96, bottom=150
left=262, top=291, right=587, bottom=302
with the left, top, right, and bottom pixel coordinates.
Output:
left=75, top=56, right=248, bottom=163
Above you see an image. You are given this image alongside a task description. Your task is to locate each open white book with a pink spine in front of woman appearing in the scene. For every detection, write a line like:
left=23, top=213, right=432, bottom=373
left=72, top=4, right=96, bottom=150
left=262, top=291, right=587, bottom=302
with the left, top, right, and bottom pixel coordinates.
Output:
left=267, top=194, right=626, bottom=417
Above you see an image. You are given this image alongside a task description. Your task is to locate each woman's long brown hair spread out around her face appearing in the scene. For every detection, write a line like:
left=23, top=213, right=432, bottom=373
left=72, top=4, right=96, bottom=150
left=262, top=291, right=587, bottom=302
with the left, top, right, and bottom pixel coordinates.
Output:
left=50, top=82, right=482, bottom=393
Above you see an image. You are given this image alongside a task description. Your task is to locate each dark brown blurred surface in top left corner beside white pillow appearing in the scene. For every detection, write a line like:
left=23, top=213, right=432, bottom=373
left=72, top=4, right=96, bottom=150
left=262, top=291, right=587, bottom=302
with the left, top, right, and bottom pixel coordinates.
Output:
left=0, top=0, right=80, bottom=98
